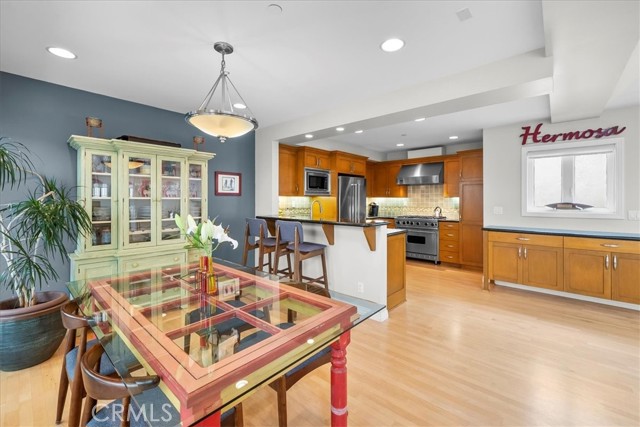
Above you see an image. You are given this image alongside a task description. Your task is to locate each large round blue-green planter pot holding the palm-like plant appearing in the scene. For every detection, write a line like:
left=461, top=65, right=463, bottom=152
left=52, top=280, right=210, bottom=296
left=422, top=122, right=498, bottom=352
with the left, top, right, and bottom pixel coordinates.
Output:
left=0, top=291, right=69, bottom=371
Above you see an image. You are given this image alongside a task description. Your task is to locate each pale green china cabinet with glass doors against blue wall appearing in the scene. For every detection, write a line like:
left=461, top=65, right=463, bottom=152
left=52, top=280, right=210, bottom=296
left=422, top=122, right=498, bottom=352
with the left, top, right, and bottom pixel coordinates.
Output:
left=68, top=135, right=215, bottom=280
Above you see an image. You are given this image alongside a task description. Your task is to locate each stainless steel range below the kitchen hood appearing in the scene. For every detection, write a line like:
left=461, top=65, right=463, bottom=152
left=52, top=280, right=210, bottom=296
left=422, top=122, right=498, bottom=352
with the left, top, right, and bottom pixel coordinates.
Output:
left=396, top=216, right=446, bottom=264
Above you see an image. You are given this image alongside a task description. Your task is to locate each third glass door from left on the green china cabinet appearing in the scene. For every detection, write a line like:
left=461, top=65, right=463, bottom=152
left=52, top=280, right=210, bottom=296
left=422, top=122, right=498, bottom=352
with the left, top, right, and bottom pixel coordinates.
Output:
left=158, top=158, right=184, bottom=243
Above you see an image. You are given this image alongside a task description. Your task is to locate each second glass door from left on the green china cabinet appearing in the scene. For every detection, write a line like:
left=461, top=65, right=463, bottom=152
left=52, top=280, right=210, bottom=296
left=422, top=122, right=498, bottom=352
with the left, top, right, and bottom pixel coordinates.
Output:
left=124, top=154, right=155, bottom=246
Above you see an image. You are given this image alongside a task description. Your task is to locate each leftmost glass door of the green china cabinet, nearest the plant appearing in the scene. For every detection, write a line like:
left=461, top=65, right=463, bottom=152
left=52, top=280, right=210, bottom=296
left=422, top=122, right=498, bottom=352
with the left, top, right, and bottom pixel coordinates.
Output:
left=86, top=152, right=117, bottom=250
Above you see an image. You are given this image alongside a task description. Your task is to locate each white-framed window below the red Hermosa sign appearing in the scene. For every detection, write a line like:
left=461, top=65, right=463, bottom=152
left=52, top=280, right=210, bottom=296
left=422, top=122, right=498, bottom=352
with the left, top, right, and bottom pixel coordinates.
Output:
left=522, top=138, right=624, bottom=218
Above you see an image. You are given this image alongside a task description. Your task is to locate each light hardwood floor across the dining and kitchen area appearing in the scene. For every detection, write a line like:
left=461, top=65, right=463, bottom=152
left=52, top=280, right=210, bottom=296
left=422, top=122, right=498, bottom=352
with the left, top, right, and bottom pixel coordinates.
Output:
left=0, top=261, right=640, bottom=426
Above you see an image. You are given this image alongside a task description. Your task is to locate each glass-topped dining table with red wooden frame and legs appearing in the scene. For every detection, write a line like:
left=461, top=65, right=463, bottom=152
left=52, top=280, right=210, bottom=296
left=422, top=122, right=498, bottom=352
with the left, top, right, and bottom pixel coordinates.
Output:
left=67, top=259, right=384, bottom=426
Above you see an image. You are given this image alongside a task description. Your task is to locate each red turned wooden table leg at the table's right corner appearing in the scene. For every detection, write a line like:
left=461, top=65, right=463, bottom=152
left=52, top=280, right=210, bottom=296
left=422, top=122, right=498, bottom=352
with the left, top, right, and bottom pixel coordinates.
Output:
left=331, top=331, right=351, bottom=427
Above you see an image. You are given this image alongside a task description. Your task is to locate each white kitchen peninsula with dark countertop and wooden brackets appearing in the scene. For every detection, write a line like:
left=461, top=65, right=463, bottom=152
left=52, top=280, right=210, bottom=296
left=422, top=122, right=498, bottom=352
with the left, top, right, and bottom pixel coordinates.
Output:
left=257, top=215, right=404, bottom=321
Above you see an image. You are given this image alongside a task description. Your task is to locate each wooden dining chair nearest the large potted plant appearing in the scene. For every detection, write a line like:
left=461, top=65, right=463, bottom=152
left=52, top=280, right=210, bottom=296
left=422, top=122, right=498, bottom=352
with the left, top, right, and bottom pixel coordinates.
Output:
left=56, top=301, right=115, bottom=427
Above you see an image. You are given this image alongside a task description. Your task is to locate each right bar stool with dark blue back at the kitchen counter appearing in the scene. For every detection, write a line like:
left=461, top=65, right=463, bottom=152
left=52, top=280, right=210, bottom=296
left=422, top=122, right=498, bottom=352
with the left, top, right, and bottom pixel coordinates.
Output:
left=274, top=220, right=329, bottom=289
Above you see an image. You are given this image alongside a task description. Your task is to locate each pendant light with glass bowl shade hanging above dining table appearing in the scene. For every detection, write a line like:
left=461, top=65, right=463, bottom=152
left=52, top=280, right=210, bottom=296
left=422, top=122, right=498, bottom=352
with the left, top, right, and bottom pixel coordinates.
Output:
left=185, top=42, right=258, bottom=142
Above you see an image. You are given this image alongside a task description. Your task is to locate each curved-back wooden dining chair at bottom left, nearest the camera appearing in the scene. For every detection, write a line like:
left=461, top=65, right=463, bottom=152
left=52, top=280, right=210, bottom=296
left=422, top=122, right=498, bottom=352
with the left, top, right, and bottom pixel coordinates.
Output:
left=80, top=345, right=243, bottom=427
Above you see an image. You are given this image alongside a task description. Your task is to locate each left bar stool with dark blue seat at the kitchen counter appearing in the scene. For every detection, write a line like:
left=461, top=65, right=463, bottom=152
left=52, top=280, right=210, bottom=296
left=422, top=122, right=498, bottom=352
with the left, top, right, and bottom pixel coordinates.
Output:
left=242, top=218, right=292, bottom=274
